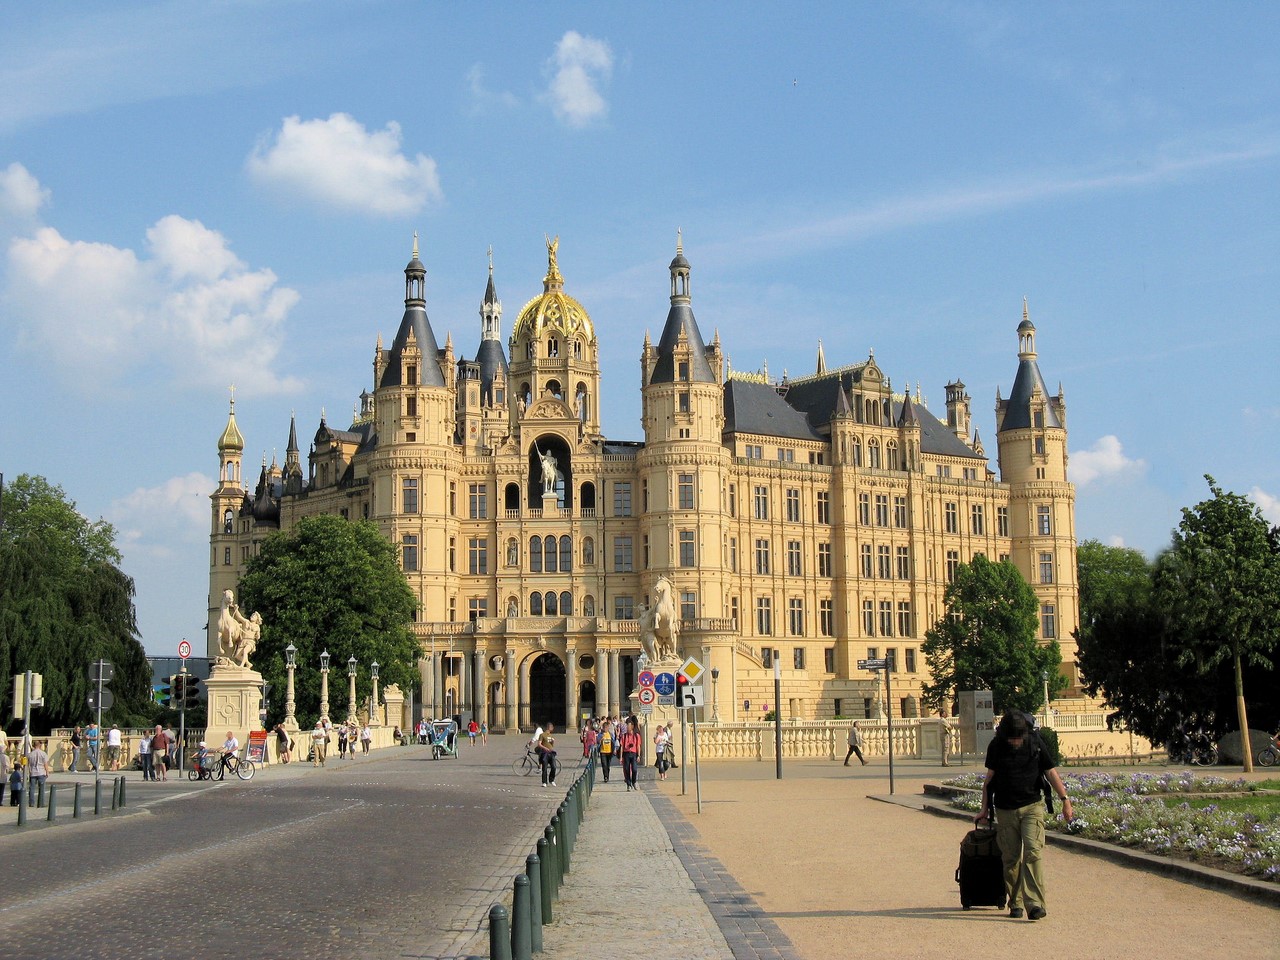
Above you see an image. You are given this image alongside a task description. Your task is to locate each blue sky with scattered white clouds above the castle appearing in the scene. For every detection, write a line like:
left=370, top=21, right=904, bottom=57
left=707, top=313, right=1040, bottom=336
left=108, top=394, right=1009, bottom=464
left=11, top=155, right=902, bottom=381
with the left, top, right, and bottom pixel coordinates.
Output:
left=0, top=0, right=1280, bottom=655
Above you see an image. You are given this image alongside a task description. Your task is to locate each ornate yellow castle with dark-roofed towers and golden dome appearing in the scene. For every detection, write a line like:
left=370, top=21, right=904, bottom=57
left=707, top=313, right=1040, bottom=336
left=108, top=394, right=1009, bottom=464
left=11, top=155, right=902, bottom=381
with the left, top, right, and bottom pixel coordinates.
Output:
left=209, top=238, right=1079, bottom=730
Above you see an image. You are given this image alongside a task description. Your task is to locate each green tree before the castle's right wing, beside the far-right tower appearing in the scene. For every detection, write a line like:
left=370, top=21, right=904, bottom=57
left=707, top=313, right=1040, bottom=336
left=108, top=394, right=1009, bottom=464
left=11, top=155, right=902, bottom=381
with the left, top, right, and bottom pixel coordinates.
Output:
left=920, top=554, right=1066, bottom=713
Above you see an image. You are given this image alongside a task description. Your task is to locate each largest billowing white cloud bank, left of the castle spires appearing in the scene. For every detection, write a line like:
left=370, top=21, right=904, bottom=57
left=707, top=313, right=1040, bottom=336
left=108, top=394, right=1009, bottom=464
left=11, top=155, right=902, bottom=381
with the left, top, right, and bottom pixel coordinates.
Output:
left=5, top=216, right=300, bottom=394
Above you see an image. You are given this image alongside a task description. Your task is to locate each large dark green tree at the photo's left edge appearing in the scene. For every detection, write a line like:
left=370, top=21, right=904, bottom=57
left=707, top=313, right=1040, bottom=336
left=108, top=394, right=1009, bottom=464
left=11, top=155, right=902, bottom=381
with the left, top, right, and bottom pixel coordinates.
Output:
left=0, top=475, right=152, bottom=733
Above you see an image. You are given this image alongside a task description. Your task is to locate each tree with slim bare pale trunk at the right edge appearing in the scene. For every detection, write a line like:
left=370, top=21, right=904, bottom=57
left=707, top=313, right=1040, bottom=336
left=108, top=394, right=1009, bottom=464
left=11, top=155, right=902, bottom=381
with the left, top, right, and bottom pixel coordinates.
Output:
left=1155, top=475, right=1280, bottom=773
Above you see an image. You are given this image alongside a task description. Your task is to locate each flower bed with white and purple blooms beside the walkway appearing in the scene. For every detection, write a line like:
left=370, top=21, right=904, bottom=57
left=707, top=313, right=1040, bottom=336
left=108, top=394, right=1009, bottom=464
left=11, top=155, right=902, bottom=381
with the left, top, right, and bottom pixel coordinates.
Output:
left=943, top=771, right=1280, bottom=882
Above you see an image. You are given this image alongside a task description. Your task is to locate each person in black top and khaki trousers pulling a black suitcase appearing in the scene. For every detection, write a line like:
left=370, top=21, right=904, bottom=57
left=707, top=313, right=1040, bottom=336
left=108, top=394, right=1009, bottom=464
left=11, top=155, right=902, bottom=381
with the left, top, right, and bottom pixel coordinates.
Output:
left=974, top=710, right=1071, bottom=920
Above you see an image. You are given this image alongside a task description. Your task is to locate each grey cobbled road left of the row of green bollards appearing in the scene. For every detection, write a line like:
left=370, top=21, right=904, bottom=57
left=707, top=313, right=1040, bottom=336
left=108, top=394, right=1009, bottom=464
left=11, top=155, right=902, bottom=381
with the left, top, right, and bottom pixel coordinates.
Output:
left=0, top=737, right=568, bottom=960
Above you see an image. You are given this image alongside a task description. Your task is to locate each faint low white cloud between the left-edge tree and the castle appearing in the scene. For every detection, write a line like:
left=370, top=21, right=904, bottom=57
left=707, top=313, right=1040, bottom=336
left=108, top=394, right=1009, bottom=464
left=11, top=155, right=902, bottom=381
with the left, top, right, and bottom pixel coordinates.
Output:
left=106, top=472, right=218, bottom=558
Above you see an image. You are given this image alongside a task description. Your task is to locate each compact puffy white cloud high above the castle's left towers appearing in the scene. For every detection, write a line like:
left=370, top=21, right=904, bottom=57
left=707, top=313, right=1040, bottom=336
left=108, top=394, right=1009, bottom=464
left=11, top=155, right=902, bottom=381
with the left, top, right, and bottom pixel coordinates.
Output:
left=246, top=114, right=442, bottom=216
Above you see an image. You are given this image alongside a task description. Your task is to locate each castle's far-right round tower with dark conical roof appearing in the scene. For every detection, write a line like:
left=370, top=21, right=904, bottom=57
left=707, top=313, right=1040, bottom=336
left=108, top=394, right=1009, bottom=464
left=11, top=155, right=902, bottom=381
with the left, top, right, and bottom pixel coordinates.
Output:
left=996, top=301, right=1079, bottom=694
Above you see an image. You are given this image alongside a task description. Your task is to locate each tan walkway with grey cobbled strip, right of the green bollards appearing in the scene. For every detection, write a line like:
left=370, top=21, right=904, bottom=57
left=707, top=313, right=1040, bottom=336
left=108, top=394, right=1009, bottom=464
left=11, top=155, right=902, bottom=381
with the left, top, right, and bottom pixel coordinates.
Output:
left=529, top=760, right=1280, bottom=960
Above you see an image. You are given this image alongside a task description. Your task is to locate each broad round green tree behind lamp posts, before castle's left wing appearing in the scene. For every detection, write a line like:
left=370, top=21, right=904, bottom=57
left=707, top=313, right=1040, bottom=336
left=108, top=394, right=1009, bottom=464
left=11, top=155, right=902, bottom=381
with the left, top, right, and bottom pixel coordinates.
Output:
left=237, top=516, right=420, bottom=723
